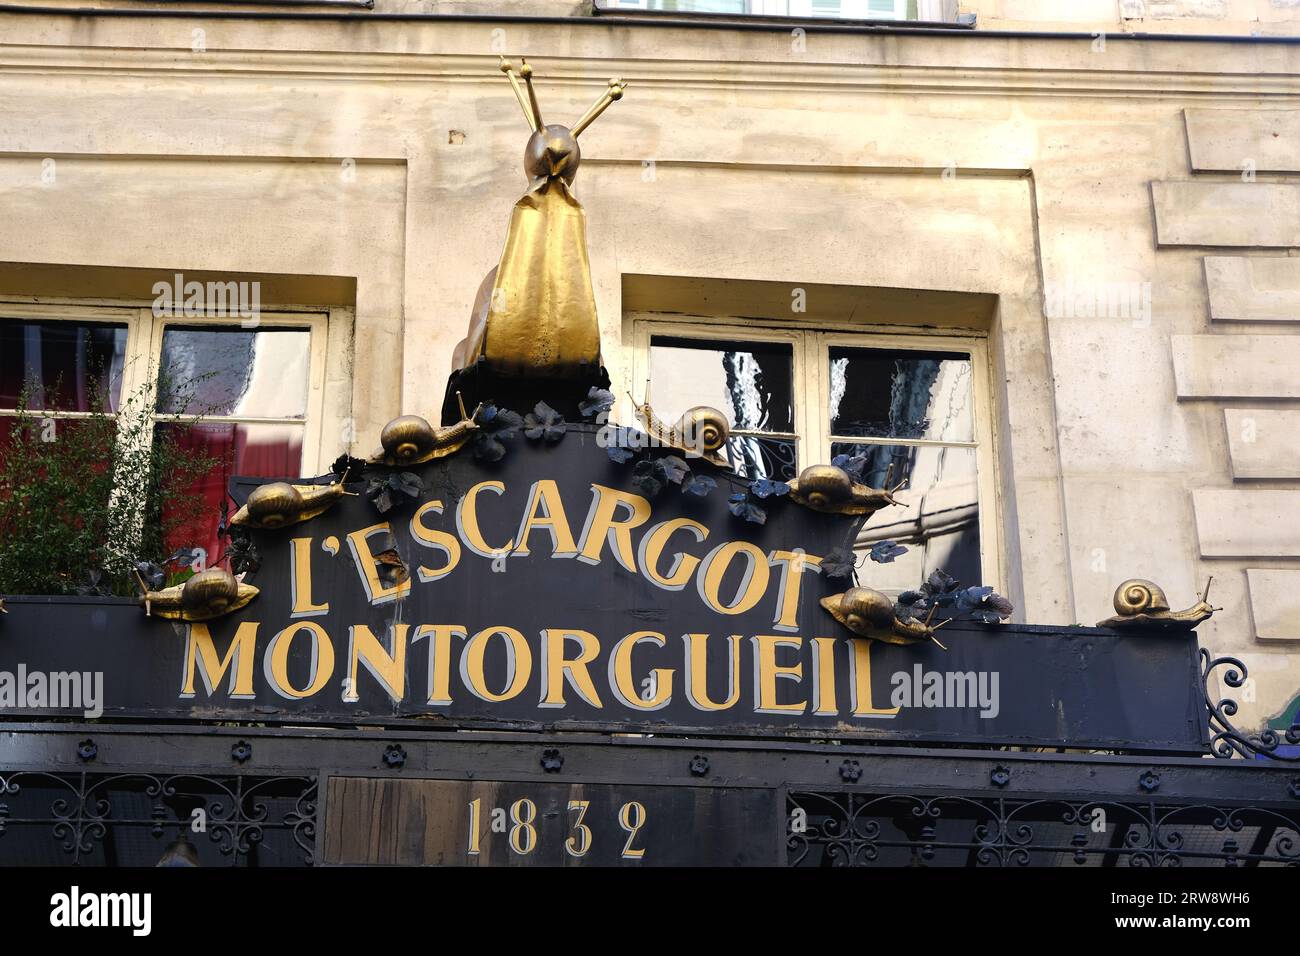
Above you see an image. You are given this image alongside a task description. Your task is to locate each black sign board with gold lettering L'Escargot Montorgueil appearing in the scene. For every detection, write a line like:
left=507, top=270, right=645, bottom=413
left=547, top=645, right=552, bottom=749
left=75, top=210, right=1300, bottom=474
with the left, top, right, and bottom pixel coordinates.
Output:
left=0, top=425, right=1204, bottom=752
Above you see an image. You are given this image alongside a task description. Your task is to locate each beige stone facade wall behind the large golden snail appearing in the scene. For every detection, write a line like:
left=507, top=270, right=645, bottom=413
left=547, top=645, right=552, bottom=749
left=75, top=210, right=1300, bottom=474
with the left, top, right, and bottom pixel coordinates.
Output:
left=0, top=7, right=1300, bottom=723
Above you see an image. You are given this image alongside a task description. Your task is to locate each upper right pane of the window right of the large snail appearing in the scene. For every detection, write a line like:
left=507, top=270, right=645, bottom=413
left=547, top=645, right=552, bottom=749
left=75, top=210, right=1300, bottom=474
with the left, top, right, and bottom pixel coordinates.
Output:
left=829, top=346, right=975, bottom=441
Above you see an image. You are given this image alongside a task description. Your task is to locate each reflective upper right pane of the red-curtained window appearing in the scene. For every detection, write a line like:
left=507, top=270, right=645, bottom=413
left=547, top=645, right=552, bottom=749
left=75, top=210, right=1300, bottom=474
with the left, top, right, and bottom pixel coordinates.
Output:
left=159, top=325, right=312, bottom=419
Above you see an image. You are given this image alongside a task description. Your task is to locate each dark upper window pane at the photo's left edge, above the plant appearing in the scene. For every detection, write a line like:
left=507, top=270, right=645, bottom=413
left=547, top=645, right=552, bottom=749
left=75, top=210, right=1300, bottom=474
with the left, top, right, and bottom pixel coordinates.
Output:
left=0, top=319, right=126, bottom=411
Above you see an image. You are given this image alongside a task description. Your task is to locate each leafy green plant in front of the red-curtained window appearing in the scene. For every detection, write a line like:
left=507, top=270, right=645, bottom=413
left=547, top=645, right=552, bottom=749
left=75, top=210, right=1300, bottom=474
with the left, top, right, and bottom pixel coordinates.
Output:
left=0, top=376, right=220, bottom=594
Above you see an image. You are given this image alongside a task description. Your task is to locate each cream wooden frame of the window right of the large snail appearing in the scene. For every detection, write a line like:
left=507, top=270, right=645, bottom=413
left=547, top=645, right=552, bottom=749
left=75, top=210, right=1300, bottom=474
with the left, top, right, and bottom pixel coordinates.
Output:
left=623, top=313, right=1006, bottom=592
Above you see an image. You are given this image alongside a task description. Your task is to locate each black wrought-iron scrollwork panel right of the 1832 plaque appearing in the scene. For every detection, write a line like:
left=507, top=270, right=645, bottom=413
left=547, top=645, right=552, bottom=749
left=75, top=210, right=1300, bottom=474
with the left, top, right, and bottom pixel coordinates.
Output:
left=787, top=792, right=1300, bottom=868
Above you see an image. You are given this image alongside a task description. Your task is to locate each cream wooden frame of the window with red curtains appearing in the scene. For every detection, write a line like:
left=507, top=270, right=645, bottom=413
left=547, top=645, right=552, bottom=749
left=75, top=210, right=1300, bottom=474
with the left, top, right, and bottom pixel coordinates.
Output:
left=0, top=299, right=329, bottom=477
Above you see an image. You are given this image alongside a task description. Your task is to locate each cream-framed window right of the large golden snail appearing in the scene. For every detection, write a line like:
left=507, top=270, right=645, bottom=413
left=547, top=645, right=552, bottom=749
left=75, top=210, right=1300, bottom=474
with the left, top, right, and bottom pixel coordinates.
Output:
left=633, top=317, right=1001, bottom=592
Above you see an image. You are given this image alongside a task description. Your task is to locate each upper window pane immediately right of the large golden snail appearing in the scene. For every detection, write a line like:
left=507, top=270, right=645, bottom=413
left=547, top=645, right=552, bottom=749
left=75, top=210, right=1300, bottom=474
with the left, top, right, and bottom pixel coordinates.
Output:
left=638, top=336, right=794, bottom=432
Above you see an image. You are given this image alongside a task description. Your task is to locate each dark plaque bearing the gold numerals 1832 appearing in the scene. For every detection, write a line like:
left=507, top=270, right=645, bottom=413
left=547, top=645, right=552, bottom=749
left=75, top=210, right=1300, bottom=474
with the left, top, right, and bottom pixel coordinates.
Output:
left=325, top=780, right=785, bottom=866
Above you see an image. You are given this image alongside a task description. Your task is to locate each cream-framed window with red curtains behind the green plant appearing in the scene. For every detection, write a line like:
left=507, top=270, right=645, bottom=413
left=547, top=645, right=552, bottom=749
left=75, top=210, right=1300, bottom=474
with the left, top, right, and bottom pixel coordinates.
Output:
left=0, top=303, right=328, bottom=561
